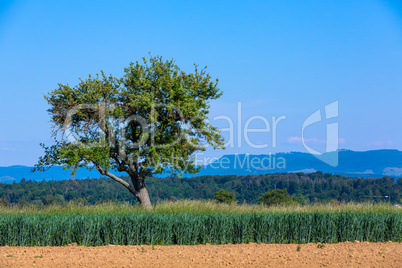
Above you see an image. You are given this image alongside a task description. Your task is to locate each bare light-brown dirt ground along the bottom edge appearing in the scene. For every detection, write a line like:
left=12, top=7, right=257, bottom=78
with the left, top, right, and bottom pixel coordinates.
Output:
left=0, top=242, right=402, bottom=267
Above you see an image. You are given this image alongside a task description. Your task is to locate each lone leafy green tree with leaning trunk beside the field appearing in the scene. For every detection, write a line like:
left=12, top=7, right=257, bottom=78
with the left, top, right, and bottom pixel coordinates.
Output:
left=34, top=56, right=223, bottom=208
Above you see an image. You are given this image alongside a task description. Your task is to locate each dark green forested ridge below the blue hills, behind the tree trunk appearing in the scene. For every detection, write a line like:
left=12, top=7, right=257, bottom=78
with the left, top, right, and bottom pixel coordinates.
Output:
left=0, top=172, right=402, bottom=205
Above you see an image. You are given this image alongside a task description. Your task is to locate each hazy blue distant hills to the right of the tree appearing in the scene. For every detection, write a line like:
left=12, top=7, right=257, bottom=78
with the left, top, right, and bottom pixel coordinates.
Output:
left=201, top=150, right=402, bottom=178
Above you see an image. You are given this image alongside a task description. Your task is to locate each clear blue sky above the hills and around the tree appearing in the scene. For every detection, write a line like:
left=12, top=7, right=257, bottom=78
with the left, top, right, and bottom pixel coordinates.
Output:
left=0, top=0, right=402, bottom=166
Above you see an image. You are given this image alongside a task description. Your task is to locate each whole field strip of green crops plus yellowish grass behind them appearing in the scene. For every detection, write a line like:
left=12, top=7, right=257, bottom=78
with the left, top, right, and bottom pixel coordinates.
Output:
left=0, top=201, right=402, bottom=246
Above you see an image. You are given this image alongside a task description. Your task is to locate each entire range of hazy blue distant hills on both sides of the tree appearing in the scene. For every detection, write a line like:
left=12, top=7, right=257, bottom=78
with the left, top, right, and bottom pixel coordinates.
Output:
left=0, top=150, right=402, bottom=183
